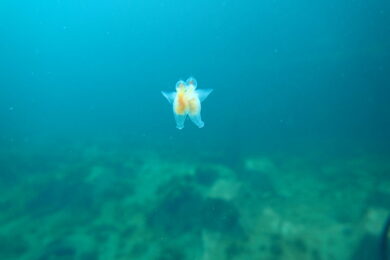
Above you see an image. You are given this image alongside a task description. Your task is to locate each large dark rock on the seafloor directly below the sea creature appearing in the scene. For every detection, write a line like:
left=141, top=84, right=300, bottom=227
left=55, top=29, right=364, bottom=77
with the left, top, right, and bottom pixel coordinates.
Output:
left=147, top=180, right=242, bottom=239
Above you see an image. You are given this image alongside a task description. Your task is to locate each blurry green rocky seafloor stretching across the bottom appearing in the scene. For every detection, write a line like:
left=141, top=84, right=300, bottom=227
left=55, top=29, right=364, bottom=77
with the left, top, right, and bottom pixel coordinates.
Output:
left=0, top=146, right=390, bottom=260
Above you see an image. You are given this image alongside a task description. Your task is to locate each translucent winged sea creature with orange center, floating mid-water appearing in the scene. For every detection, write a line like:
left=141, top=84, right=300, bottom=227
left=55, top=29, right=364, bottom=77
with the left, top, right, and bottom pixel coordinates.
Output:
left=161, top=78, right=213, bottom=129
